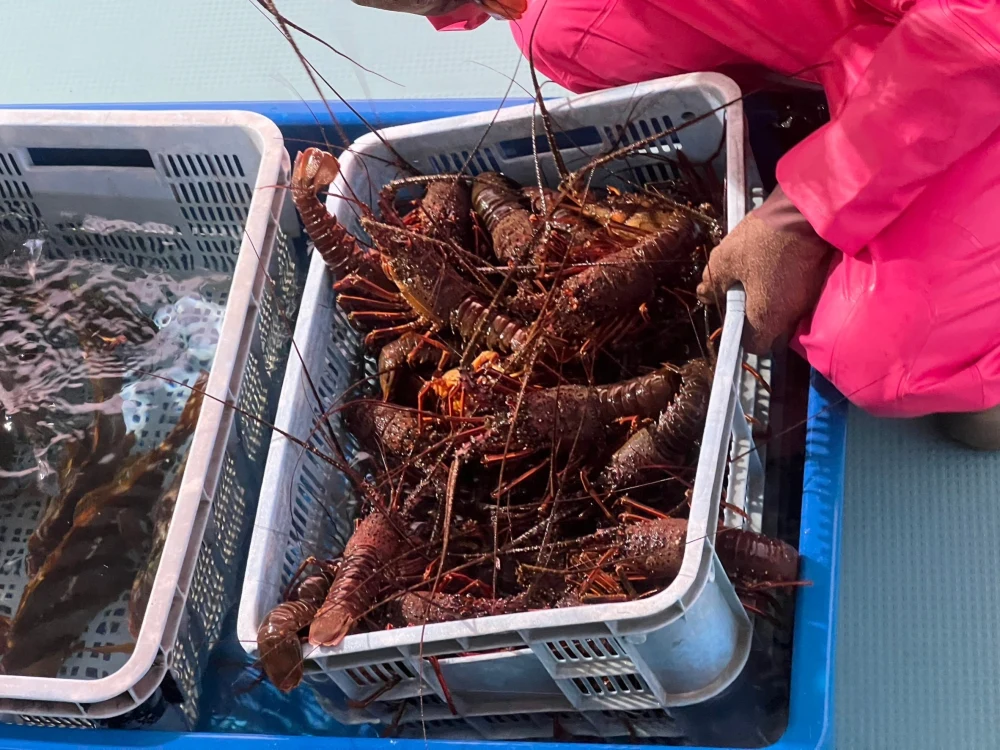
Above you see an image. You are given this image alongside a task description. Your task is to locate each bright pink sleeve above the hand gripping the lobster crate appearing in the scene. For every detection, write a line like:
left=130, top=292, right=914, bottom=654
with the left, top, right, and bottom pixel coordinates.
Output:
left=778, top=0, right=1000, bottom=256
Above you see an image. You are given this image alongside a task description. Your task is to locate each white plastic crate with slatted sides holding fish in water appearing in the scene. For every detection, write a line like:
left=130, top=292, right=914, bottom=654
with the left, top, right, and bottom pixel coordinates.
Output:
left=0, top=110, right=294, bottom=725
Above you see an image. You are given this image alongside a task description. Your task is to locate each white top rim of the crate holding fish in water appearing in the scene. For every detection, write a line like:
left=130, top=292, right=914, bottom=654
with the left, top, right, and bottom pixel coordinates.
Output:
left=0, top=107, right=290, bottom=718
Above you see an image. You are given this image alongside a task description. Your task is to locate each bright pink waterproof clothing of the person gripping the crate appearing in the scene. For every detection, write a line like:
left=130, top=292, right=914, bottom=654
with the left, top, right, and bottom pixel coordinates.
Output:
left=432, top=0, right=1000, bottom=416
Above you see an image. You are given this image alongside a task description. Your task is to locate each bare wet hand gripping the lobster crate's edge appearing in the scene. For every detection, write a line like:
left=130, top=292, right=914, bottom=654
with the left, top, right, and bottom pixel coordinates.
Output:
left=698, top=193, right=832, bottom=354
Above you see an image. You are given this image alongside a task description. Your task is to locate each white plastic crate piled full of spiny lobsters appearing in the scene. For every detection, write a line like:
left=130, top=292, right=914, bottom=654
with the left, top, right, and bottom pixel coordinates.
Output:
left=238, top=74, right=762, bottom=737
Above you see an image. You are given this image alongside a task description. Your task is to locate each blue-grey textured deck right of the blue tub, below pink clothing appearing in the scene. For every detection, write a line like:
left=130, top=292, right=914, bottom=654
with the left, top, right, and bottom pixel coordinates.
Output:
left=836, top=410, right=1000, bottom=750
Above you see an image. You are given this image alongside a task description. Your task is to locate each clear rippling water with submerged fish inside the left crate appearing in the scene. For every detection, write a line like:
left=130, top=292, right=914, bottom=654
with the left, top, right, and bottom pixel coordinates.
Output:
left=0, top=237, right=230, bottom=679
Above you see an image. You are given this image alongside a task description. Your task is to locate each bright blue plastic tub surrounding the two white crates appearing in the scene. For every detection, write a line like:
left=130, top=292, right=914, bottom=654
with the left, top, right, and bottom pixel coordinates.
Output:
left=0, top=100, right=847, bottom=750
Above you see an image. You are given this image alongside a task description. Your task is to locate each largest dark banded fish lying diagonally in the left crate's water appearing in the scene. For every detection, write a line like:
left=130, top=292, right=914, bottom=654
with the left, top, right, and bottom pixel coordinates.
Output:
left=0, top=373, right=208, bottom=677
